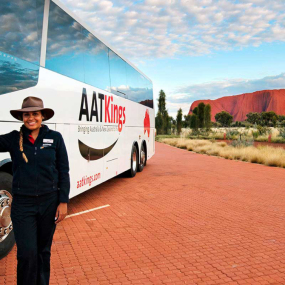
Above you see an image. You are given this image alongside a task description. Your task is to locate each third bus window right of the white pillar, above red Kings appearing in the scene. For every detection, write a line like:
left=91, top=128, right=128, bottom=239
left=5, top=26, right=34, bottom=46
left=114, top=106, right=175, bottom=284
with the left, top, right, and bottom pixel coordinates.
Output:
left=109, top=49, right=128, bottom=98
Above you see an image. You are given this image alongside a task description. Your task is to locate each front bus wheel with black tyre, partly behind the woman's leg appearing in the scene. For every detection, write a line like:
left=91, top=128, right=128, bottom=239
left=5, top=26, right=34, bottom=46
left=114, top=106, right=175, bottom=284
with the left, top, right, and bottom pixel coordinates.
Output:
left=0, top=172, right=15, bottom=259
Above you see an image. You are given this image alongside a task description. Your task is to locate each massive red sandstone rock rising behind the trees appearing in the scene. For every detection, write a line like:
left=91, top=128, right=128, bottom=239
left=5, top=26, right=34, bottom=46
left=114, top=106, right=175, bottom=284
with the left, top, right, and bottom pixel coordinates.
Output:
left=189, top=89, right=285, bottom=121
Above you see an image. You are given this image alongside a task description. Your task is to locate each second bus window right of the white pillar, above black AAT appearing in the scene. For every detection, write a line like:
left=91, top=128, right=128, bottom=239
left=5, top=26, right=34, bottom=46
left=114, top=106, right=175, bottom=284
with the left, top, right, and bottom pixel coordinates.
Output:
left=83, top=28, right=110, bottom=90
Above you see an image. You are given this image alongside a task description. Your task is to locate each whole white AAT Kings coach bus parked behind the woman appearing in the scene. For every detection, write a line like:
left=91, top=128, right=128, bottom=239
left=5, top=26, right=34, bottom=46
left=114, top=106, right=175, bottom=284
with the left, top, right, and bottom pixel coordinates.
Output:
left=0, top=0, right=155, bottom=258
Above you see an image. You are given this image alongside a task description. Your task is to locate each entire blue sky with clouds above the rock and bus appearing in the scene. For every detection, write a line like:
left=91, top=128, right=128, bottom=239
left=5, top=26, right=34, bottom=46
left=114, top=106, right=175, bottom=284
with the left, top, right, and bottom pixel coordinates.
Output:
left=61, top=0, right=285, bottom=117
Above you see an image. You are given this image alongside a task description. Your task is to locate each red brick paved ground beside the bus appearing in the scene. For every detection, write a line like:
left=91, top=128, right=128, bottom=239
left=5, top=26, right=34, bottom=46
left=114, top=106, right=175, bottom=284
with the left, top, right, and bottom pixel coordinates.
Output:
left=0, top=143, right=285, bottom=285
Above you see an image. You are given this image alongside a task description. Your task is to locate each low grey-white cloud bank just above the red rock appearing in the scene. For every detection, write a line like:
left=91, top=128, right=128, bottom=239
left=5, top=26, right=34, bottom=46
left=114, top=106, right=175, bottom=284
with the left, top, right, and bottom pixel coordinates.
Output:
left=168, top=73, right=285, bottom=107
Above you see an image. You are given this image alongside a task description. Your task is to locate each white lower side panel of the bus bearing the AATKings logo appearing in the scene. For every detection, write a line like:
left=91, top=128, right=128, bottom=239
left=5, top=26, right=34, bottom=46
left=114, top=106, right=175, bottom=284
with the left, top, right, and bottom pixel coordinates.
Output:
left=0, top=68, right=155, bottom=198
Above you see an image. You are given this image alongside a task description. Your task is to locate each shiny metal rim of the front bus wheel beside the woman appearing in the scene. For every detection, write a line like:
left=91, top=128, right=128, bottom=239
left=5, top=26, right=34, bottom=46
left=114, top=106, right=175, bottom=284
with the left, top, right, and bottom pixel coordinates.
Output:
left=0, top=190, right=13, bottom=243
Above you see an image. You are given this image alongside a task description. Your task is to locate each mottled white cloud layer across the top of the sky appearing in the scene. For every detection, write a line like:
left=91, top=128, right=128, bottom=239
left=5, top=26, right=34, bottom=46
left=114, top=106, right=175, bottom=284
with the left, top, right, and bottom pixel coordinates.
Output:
left=58, top=0, right=285, bottom=59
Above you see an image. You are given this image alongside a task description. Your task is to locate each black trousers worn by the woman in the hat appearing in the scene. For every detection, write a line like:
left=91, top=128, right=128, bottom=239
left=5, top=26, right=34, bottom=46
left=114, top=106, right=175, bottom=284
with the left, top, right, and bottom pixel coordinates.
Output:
left=11, top=191, right=59, bottom=285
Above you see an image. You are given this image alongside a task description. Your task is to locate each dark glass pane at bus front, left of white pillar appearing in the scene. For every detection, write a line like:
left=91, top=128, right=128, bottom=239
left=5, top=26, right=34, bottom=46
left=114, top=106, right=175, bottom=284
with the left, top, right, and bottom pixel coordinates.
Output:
left=0, top=0, right=44, bottom=95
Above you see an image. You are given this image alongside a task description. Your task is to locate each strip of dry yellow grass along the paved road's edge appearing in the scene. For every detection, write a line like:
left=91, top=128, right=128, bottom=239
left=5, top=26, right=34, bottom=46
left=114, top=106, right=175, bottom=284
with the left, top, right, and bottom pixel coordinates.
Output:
left=161, top=138, right=285, bottom=168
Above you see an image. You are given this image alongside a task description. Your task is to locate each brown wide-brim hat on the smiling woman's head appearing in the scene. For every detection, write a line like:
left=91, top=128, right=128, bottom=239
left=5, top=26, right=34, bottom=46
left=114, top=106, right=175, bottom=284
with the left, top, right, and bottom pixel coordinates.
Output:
left=10, top=96, right=54, bottom=121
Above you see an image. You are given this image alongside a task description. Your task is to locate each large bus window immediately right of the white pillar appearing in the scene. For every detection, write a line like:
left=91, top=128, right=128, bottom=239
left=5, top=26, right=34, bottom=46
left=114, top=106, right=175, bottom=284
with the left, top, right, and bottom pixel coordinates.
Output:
left=45, top=1, right=85, bottom=82
